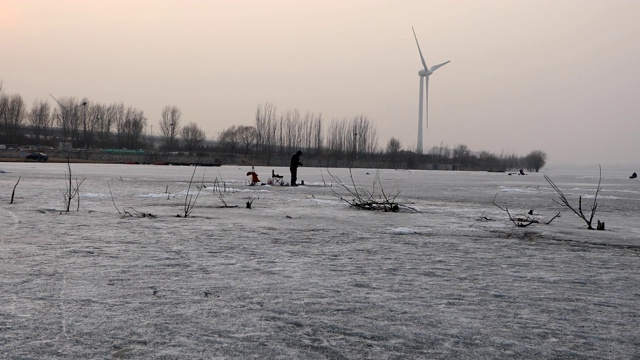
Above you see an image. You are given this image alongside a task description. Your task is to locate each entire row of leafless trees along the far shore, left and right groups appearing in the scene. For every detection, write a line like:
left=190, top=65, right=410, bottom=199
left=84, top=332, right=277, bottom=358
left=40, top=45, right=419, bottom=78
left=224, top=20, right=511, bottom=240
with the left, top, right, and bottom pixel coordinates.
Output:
left=0, top=83, right=547, bottom=171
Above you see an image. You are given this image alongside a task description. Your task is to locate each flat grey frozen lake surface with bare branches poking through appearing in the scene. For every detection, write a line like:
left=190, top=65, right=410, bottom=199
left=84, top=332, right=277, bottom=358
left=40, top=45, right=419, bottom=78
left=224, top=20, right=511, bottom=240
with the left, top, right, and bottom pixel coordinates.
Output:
left=0, top=163, right=640, bottom=359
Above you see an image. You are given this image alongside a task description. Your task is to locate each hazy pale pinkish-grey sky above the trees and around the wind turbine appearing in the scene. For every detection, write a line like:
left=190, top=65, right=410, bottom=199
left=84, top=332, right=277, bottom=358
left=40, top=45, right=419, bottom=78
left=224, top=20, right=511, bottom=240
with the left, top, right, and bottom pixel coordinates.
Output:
left=0, top=0, right=640, bottom=167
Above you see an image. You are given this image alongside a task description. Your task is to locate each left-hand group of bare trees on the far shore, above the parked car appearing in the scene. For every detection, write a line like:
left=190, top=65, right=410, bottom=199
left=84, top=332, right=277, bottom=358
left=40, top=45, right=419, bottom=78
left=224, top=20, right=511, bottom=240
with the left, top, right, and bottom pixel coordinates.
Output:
left=0, top=84, right=205, bottom=151
